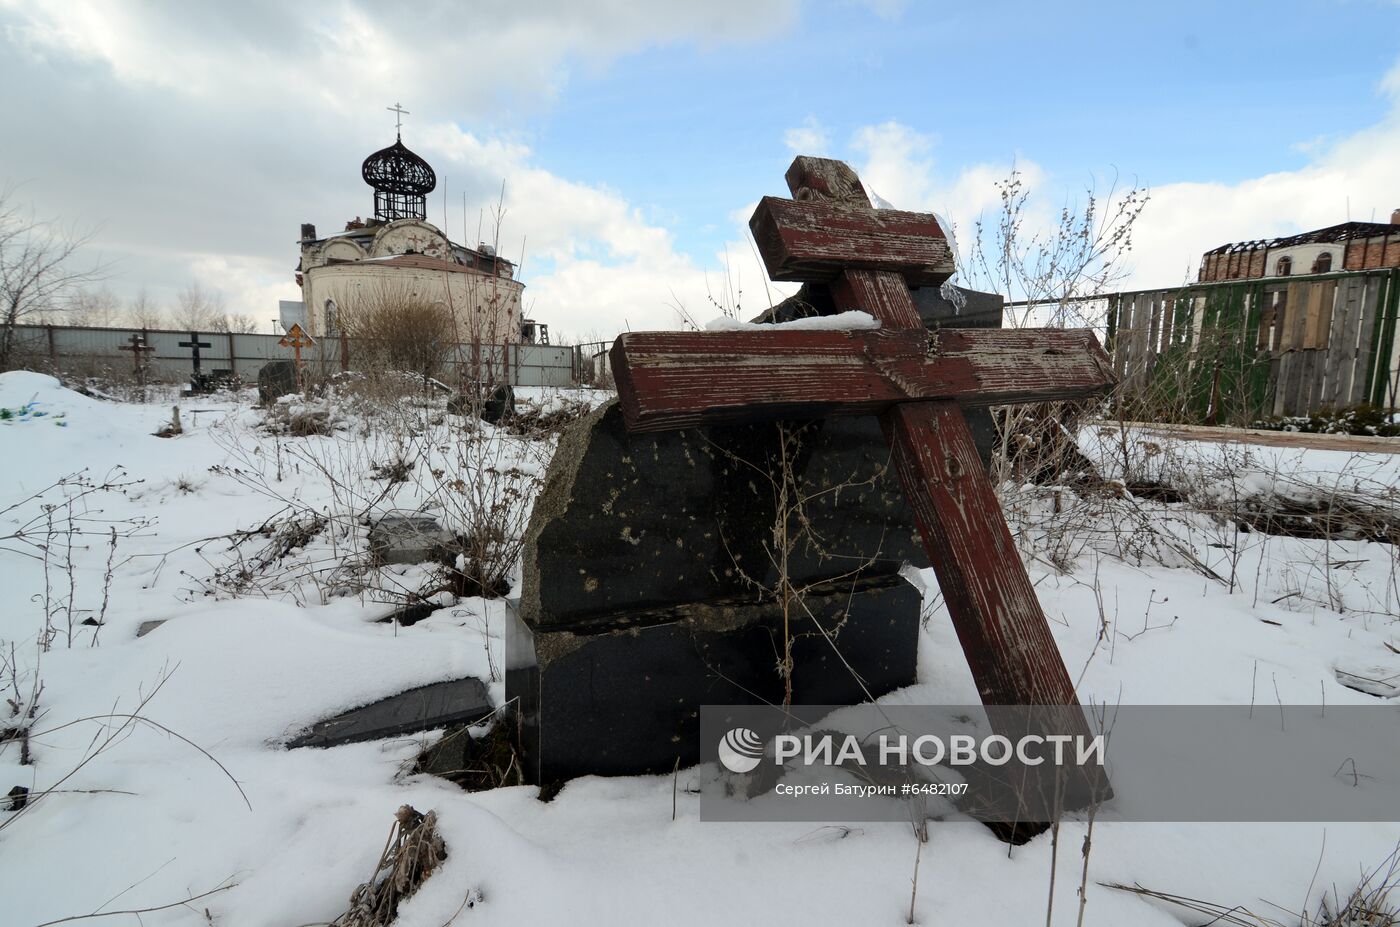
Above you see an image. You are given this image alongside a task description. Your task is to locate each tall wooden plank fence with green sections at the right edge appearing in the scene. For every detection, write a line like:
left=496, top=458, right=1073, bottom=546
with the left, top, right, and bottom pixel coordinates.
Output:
left=1107, top=269, right=1400, bottom=421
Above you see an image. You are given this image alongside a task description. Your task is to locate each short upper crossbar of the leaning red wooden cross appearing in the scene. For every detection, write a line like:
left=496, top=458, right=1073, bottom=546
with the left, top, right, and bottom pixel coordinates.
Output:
left=749, top=196, right=953, bottom=287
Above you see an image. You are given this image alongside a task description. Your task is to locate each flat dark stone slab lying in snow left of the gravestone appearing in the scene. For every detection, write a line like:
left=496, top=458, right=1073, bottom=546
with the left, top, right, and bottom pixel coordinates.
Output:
left=287, top=676, right=494, bottom=748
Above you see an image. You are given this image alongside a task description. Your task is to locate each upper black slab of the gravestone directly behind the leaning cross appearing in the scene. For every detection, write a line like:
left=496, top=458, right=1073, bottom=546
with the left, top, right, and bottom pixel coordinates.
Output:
left=521, top=400, right=928, bottom=629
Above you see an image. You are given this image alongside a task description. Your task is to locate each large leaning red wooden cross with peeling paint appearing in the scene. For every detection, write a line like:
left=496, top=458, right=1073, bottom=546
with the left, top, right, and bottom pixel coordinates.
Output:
left=610, top=157, right=1113, bottom=812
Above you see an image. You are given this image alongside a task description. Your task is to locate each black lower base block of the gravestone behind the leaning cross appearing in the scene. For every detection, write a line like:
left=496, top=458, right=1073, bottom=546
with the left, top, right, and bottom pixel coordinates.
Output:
left=505, top=576, right=923, bottom=784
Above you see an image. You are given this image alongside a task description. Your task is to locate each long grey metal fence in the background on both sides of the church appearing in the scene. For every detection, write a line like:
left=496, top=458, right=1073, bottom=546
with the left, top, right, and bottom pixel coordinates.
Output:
left=4, top=325, right=578, bottom=386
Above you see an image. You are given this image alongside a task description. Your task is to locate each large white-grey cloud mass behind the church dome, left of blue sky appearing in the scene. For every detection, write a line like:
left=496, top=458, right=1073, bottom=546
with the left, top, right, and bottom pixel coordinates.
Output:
left=0, top=0, right=797, bottom=336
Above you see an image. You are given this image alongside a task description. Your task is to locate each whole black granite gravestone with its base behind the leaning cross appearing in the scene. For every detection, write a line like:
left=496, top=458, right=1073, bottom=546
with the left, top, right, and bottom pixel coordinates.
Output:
left=505, top=403, right=927, bottom=783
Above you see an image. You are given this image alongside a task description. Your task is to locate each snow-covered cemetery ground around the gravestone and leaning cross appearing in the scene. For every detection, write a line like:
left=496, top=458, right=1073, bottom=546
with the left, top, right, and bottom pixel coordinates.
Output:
left=0, top=372, right=1400, bottom=927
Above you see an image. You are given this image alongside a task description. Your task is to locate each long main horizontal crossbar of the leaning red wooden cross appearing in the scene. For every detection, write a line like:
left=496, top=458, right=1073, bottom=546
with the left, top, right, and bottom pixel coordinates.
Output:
left=610, top=329, right=1114, bottom=431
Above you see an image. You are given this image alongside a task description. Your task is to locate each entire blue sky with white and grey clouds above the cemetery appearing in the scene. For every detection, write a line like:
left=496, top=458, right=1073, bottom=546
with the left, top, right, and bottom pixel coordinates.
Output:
left=0, top=0, right=1400, bottom=339
